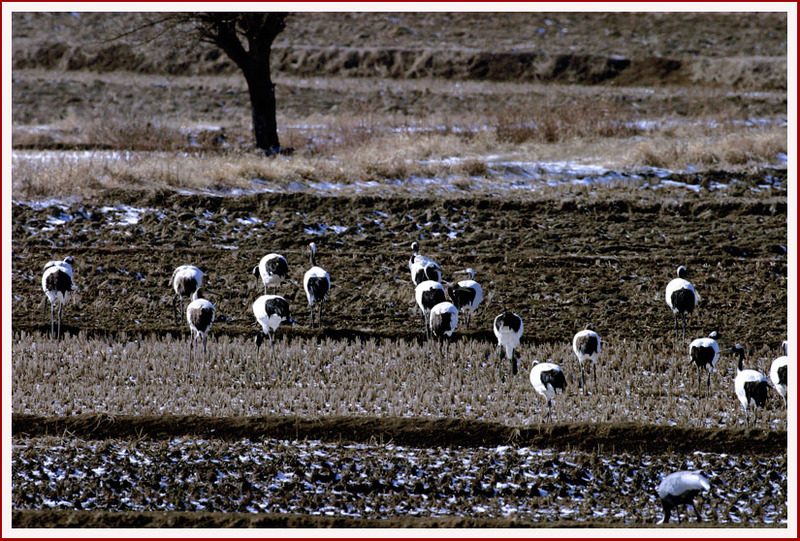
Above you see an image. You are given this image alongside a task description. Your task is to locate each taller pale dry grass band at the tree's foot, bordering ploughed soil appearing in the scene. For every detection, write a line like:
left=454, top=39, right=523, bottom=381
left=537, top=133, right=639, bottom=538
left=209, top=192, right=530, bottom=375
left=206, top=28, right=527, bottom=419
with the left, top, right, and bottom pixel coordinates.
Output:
left=12, top=117, right=787, bottom=199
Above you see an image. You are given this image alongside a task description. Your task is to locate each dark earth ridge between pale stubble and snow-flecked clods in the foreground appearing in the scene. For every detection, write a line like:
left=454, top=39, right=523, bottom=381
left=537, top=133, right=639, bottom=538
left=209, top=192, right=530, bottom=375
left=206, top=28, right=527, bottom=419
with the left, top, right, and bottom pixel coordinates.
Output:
left=12, top=413, right=787, bottom=455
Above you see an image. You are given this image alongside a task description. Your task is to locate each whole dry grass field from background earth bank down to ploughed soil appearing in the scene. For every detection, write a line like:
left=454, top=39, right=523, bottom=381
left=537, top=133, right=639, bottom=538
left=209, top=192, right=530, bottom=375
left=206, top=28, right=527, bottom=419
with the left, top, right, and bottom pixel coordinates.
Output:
left=12, top=60, right=787, bottom=199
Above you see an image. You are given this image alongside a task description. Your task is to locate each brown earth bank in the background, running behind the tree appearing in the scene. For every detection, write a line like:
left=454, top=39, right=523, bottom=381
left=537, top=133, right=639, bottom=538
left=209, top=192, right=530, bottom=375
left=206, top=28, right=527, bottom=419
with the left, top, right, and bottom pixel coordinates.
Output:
left=13, top=42, right=787, bottom=90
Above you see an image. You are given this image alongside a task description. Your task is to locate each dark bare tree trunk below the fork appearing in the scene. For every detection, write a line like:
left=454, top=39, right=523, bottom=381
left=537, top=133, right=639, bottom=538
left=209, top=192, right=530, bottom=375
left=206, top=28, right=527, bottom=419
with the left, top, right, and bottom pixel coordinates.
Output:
left=244, top=61, right=281, bottom=154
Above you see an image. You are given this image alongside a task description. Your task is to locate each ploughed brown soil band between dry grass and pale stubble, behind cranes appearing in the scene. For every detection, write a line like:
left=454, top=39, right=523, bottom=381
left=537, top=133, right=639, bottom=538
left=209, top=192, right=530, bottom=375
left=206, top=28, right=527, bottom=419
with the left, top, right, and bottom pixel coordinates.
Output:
left=12, top=186, right=787, bottom=348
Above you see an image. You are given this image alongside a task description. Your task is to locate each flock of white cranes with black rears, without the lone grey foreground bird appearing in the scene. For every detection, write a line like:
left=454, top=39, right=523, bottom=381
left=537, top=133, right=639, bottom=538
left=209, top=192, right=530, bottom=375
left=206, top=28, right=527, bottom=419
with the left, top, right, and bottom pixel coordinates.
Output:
left=42, top=246, right=788, bottom=427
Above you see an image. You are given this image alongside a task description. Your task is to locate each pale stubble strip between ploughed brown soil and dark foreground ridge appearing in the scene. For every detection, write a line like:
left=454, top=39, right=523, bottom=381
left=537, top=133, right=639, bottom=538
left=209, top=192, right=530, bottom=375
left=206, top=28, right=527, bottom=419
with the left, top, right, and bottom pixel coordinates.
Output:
left=12, top=330, right=785, bottom=427
